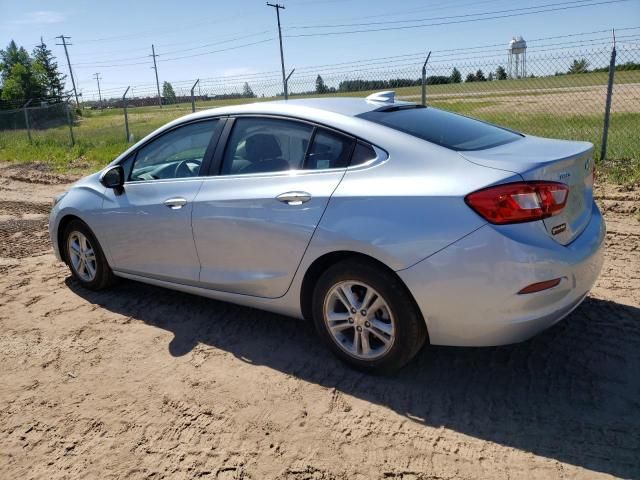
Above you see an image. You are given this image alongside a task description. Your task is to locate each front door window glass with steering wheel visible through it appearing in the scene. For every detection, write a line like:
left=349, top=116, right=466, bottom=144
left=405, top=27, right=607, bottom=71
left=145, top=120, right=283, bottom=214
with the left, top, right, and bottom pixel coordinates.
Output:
left=129, top=120, right=218, bottom=182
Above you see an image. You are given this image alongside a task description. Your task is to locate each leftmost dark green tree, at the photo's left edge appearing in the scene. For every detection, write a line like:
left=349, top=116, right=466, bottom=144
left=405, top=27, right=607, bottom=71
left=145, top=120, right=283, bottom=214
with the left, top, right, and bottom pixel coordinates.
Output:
left=0, top=40, right=46, bottom=100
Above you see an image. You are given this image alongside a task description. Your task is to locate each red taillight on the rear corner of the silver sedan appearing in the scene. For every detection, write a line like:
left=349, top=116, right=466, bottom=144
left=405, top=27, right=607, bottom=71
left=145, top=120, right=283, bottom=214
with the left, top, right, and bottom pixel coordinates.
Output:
left=464, top=182, right=569, bottom=225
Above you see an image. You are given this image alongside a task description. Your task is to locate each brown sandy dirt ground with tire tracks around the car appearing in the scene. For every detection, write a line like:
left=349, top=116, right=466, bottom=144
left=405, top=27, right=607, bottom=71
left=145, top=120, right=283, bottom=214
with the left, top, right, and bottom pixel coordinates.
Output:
left=0, top=164, right=640, bottom=480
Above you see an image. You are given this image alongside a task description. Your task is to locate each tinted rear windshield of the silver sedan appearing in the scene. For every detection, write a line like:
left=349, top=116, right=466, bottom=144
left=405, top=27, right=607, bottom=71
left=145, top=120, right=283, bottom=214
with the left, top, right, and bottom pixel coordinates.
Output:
left=360, top=107, right=522, bottom=151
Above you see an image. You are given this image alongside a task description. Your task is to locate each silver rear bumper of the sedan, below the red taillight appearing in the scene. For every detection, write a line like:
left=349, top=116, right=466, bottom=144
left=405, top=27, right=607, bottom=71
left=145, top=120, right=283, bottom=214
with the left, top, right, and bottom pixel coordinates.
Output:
left=397, top=203, right=605, bottom=346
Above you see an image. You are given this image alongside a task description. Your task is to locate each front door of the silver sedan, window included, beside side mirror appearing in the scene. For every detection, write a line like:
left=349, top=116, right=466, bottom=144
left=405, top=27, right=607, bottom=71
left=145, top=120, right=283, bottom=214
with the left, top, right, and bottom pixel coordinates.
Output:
left=101, top=119, right=224, bottom=283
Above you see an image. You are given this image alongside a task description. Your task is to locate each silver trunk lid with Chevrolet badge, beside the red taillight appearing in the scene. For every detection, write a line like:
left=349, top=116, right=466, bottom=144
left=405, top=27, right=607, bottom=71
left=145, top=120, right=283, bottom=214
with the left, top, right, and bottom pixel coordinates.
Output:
left=461, top=136, right=593, bottom=245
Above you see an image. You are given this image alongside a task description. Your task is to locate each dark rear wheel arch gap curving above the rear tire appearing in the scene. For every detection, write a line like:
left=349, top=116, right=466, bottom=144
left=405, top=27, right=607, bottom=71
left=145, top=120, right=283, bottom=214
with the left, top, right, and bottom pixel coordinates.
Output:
left=300, top=250, right=428, bottom=340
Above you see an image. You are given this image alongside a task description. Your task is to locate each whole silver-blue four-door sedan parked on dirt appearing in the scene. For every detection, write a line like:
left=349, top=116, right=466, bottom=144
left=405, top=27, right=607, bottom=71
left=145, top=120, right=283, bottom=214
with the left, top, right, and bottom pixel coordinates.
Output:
left=49, top=92, right=605, bottom=372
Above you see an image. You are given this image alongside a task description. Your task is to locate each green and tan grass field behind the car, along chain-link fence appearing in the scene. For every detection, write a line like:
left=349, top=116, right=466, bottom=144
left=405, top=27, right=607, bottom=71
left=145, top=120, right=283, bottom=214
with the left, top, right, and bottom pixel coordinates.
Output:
left=0, top=71, right=640, bottom=183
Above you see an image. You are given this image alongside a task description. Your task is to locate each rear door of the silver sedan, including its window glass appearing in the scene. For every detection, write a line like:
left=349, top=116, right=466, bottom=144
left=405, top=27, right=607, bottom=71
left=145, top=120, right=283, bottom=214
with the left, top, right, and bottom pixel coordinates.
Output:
left=193, top=116, right=355, bottom=298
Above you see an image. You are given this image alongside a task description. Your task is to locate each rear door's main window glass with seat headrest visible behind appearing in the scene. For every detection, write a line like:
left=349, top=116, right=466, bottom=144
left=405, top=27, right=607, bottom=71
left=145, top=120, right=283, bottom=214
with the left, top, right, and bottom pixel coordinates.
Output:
left=222, top=118, right=313, bottom=175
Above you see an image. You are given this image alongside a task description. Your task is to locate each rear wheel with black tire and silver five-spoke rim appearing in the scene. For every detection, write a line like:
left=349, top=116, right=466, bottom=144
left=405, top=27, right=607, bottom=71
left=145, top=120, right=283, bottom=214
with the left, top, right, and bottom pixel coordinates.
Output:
left=312, top=260, right=427, bottom=373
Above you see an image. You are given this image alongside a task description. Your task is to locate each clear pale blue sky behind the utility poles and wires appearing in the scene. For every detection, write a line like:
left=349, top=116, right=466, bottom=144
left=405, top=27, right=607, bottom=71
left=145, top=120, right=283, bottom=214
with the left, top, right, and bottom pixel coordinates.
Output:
left=0, top=0, right=640, bottom=96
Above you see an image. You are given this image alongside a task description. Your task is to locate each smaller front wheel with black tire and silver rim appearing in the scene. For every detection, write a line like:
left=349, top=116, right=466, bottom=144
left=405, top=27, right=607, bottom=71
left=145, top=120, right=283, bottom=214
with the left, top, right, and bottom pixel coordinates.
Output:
left=61, top=220, right=115, bottom=290
